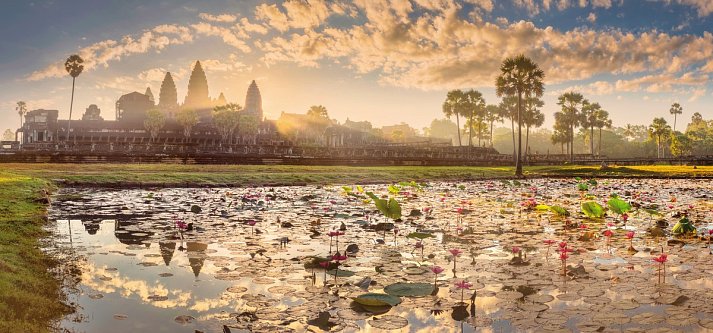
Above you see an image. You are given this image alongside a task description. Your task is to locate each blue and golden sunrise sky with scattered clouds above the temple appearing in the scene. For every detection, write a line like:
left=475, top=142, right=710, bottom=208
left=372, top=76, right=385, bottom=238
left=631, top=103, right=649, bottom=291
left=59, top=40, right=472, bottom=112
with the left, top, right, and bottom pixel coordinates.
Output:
left=0, top=0, right=713, bottom=131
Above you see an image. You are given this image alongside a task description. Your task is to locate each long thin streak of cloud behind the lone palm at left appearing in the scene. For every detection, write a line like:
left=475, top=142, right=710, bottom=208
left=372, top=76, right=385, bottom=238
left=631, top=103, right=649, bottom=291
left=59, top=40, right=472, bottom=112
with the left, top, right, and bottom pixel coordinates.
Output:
left=27, top=25, right=193, bottom=81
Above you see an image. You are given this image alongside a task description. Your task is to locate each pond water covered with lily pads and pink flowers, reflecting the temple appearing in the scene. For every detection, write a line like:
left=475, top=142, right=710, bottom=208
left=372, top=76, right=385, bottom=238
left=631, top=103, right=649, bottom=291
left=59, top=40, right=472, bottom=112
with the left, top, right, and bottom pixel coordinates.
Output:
left=50, top=179, right=713, bottom=332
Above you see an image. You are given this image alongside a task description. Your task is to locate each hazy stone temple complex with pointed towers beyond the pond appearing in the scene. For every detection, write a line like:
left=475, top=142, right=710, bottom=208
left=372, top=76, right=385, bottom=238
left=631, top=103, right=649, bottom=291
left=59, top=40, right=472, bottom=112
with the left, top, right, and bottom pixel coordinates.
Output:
left=8, top=61, right=500, bottom=165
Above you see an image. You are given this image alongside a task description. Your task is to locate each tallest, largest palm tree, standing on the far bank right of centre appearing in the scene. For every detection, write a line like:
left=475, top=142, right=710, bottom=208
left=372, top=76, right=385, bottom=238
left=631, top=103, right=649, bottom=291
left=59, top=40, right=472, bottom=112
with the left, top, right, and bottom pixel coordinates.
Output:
left=495, top=55, right=545, bottom=177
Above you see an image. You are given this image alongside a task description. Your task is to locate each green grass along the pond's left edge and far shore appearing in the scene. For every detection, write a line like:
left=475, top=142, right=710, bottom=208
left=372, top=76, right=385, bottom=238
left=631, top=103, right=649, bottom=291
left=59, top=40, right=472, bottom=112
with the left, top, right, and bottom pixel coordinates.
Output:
left=0, top=164, right=713, bottom=332
